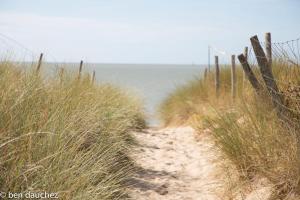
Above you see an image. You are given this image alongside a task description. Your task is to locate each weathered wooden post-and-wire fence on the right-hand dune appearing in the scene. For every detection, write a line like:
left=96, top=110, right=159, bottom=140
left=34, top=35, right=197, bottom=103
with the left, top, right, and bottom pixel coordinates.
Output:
left=206, top=33, right=300, bottom=124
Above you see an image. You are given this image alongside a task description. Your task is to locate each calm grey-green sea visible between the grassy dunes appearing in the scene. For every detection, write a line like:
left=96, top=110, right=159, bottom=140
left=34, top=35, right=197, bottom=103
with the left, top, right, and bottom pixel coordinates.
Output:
left=43, top=63, right=206, bottom=126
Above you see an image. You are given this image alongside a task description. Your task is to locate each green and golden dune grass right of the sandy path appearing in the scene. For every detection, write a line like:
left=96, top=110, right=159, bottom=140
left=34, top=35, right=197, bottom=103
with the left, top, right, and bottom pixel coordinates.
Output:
left=161, top=60, right=300, bottom=199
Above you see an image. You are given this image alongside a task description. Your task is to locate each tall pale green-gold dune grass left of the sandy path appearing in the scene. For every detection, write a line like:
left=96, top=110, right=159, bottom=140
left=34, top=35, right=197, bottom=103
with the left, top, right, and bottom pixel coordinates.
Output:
left=0, top=61, right=145, bottom=200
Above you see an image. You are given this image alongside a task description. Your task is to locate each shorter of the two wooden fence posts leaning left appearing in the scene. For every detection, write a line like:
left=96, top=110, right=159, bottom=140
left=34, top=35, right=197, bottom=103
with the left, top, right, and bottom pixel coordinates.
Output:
left=238, top=54, right=262, bottom=94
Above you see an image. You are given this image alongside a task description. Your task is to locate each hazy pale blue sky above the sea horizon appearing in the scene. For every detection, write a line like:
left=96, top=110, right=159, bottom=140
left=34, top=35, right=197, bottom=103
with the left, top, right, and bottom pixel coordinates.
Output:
left=0, top=0, right=300, bottom=64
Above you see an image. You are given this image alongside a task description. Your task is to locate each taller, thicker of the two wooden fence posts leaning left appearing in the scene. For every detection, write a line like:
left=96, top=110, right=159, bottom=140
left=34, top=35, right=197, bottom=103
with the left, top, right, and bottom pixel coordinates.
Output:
left=250, top=35, right=283, bottom=112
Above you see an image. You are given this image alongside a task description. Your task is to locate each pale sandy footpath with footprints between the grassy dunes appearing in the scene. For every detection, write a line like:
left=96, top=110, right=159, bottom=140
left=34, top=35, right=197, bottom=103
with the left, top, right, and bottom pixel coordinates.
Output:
left=130, top=127, right=230, bottom=200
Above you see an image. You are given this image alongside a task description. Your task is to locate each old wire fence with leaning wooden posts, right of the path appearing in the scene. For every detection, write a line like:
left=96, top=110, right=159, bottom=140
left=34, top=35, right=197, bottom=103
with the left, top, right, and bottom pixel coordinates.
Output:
left=209, top=33, right=300, bottom=125
